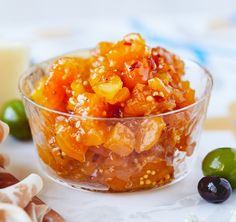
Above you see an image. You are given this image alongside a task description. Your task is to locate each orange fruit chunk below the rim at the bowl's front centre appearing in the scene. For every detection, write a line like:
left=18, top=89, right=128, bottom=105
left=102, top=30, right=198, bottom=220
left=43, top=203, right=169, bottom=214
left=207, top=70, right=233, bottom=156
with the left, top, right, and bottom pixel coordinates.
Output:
left=104, top=123, right=135, bottom=156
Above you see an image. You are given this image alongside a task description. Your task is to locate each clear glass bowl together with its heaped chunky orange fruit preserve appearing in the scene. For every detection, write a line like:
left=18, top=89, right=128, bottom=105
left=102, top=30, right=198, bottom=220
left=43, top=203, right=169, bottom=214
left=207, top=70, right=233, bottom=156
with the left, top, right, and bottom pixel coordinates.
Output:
left=20, top=33, right=211, bottom=192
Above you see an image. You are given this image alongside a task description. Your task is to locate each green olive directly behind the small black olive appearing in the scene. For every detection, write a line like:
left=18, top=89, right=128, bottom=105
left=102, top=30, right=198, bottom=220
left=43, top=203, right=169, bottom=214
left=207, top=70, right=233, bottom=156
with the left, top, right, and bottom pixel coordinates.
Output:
left=202, top=147, right=236, bottom=188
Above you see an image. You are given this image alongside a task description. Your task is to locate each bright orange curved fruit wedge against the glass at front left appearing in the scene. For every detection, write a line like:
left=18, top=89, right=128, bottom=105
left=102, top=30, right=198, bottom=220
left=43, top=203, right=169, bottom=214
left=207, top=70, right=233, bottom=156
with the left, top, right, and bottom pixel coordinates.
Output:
left=55, top=118, right=88, bottom=162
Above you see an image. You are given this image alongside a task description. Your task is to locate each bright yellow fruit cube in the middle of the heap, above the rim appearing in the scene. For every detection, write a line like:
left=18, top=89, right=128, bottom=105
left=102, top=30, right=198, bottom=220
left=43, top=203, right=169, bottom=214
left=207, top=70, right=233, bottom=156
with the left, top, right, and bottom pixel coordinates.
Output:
left=92, top=75, right=123, bottom=100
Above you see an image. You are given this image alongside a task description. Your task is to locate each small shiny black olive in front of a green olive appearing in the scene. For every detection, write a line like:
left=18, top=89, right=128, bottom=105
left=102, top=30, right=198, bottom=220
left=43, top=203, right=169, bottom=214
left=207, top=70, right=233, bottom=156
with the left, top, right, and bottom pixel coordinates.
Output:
left=198, top=176, right=232, bottom=203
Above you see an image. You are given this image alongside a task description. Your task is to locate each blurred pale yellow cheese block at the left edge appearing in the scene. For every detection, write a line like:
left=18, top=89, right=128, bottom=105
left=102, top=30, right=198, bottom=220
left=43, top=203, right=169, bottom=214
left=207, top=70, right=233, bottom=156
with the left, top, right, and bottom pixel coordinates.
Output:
left=0, top=40, right=29, bottom=106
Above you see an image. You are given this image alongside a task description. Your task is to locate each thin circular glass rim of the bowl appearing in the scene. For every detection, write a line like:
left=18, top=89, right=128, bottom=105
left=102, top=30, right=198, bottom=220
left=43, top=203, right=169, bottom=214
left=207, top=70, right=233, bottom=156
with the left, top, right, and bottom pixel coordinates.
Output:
left=18, top=49, right=214, bottom=121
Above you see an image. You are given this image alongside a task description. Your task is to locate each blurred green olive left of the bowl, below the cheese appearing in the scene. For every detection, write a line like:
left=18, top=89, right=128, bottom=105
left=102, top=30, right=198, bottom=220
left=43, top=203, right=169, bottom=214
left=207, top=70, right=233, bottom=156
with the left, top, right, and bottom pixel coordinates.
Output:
left=0, top=99, right=32, bottom=140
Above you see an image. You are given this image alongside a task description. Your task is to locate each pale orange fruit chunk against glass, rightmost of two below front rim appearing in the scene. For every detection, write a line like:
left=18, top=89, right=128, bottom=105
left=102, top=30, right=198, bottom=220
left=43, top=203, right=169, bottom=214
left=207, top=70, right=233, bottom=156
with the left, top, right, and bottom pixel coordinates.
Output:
left=135, top=117, right=166, bottom=153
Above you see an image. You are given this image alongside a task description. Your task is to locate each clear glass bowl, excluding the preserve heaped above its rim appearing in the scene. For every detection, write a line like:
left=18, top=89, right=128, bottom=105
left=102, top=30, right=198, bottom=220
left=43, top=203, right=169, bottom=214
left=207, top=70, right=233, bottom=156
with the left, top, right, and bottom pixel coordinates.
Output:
left=19, top=51, right=213, bottom=192
